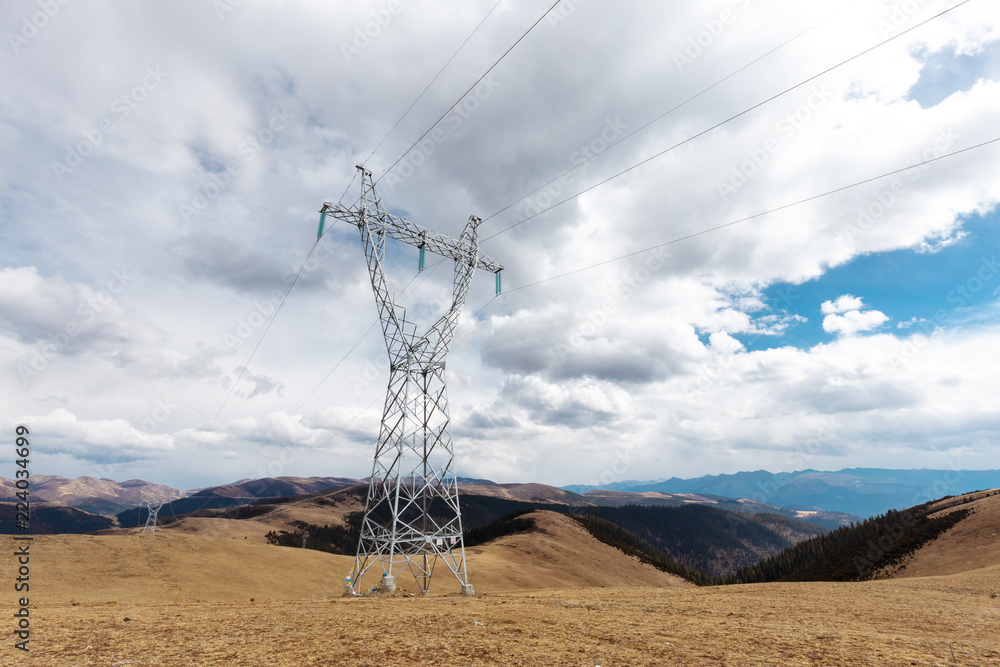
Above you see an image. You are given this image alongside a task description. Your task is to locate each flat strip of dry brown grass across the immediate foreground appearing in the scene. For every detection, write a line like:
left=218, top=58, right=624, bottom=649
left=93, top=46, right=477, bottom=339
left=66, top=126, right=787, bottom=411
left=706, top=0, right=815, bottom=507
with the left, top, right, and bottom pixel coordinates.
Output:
left=15, top=566, right=1000, bottom=667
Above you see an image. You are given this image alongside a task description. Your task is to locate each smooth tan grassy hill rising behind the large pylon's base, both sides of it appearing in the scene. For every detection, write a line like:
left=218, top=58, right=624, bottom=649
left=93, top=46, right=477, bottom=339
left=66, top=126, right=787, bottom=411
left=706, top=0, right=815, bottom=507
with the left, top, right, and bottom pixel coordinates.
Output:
left=3, top=512, right=688, bottom=604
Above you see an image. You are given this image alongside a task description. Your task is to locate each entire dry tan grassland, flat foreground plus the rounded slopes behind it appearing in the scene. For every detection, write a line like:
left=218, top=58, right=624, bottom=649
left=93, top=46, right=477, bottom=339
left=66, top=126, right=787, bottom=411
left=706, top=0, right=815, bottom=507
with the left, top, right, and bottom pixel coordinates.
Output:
left=7, top=497, right=1000, bottom=667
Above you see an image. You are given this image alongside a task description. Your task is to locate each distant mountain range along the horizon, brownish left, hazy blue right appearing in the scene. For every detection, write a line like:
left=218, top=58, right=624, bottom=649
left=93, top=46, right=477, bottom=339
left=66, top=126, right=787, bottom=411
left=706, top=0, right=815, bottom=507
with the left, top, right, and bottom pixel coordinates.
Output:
left=9, top=468, right=1000, bottom=528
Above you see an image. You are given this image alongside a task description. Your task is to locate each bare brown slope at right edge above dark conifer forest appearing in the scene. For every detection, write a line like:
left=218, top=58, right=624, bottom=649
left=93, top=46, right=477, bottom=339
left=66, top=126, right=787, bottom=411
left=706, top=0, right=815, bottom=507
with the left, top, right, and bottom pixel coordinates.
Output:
left=890, top=490, right=1000, bottom=578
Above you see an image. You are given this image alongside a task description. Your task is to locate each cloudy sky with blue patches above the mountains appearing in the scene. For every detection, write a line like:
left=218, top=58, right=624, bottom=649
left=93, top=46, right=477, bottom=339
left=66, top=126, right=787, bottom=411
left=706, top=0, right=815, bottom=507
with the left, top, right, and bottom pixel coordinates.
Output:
left=0, top=0, right=1000, bottom=489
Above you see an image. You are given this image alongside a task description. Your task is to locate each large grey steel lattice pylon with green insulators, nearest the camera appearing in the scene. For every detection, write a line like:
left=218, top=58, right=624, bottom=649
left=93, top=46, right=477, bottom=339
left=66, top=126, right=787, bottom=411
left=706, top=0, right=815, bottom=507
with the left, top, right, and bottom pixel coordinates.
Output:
left=317, top=167, right=503, bottom=595
